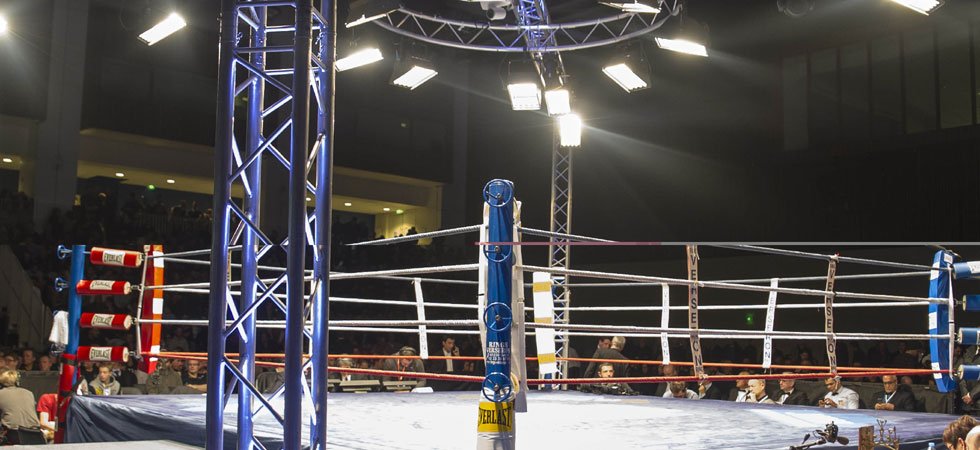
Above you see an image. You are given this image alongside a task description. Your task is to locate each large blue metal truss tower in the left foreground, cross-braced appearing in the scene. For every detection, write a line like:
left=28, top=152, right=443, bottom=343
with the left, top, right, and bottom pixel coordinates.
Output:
left=206, top=0, right=336, bottom=450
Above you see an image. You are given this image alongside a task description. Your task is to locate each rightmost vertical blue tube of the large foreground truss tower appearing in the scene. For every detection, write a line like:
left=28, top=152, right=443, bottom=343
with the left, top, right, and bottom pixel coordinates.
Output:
left=310, top=0, right=337, bottom=450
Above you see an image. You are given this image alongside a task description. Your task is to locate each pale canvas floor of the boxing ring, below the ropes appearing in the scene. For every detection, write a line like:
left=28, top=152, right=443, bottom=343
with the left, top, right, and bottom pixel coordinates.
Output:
left=67, top=391, right=954, bottom=450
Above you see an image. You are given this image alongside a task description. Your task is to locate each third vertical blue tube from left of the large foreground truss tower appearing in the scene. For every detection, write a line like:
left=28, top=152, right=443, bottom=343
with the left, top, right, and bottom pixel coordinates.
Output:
left=282, top=0, right=313, bottom=450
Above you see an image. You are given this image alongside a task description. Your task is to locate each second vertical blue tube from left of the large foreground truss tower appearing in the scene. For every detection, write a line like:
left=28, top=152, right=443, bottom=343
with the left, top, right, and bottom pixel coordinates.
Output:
left=238, top=8, right=268, bottom=449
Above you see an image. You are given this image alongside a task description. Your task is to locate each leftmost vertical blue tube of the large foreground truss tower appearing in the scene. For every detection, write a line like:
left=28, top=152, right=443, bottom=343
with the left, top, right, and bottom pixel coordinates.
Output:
left=205, top=0, right=238, bottom=450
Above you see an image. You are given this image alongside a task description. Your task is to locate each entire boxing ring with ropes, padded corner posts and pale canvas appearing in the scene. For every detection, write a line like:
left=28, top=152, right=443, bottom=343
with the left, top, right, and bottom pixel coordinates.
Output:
left=49, top=180, right=980, bottom=449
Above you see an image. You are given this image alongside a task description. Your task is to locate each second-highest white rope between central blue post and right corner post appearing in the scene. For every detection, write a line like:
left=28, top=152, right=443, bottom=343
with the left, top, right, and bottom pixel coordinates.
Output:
left=520, top=265, right=949, bottom=304
